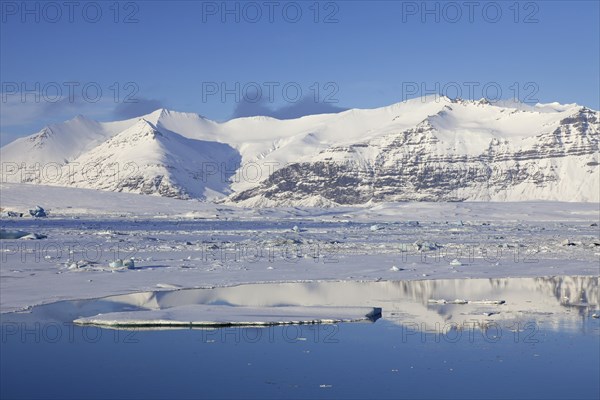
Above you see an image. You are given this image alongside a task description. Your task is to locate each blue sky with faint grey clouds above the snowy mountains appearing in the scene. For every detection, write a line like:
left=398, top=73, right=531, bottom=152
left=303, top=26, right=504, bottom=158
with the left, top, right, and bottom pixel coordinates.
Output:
left=0, top=0, right=600, bottom=144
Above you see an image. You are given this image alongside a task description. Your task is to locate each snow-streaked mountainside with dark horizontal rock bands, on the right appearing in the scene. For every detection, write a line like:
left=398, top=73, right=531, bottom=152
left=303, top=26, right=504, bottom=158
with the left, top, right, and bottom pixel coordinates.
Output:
left=231, top=104, right=600, bottom=205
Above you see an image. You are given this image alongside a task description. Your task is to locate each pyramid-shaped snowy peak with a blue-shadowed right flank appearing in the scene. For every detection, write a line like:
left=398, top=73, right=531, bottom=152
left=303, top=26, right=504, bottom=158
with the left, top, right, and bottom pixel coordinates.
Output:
left=59, top=118, right=239, bottom=199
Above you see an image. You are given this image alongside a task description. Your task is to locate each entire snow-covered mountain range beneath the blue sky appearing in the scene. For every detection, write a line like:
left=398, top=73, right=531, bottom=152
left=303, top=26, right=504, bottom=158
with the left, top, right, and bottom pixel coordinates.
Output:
left=0, top=96, right=600, bottom=206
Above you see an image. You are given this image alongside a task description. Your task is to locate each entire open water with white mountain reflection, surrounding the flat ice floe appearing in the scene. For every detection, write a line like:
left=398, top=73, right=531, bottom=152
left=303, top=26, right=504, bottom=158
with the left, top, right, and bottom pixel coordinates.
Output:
left=0, top=277, right=600, bottom=399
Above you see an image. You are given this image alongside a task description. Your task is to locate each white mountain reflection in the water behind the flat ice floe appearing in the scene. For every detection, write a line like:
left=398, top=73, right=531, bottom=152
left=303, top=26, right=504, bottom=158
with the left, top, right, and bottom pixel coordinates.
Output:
left=19, top=276, right=600, bottom=327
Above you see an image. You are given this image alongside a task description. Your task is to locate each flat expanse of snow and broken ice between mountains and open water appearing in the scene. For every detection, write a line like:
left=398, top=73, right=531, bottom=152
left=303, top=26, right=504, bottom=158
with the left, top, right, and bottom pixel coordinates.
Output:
left=0, top=184, right=600, bottom=314
